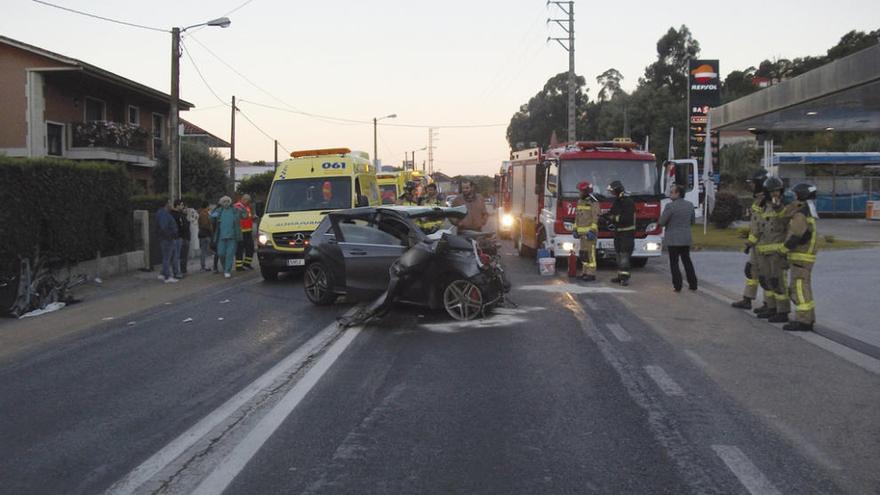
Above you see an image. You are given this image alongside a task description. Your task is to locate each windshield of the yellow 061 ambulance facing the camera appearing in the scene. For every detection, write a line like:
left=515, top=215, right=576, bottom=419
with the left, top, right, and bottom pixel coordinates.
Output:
left=266, top=177, right=352, bottom=213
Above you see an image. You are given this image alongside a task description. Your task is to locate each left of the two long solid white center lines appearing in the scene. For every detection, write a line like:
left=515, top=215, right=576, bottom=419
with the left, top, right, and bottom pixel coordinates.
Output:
left=107, top=308, right=357, bottom=494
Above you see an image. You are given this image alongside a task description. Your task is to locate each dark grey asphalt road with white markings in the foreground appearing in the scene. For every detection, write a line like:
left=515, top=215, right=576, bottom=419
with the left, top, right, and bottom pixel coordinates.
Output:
left=0, top=246, right=880, bottom=494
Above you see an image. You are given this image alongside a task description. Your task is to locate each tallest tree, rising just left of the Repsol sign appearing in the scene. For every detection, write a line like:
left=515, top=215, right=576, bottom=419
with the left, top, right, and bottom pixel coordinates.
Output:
left=645, top=25, right=700, bottom=98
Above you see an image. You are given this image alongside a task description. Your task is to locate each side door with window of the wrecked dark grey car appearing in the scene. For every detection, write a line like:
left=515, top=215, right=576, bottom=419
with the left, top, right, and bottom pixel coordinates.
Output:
left=338, top=215, right=408, bottom=299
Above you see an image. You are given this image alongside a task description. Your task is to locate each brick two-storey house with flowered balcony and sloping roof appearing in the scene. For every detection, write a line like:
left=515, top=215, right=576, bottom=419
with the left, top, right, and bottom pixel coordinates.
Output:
left=0, top=36, right=194, bottom=192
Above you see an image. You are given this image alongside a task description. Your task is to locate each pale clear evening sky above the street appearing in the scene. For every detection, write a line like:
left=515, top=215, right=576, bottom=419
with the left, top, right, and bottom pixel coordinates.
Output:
left=0, top=0, right=880, bottom=175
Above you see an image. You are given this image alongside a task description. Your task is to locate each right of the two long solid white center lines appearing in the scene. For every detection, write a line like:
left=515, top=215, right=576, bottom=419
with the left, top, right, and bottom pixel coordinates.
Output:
left=192, top=327, right=362, bottom=495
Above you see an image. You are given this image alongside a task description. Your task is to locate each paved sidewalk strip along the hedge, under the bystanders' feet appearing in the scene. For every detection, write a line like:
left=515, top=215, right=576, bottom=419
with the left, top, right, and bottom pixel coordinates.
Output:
left=0, top=259, right=260, bottom=361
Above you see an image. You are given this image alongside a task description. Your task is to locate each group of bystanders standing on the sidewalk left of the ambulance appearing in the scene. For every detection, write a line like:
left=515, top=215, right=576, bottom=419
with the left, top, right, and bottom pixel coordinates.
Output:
left=155, top=194, right=254, bottom=283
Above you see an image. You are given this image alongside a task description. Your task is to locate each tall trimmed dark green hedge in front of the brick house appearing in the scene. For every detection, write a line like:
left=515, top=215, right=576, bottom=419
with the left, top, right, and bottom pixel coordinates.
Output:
left=0, top=156, right=133, bottom=265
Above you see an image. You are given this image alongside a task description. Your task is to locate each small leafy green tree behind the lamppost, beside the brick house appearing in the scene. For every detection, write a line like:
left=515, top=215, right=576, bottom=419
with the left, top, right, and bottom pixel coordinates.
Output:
left=153, top=143, right=227, bottom=200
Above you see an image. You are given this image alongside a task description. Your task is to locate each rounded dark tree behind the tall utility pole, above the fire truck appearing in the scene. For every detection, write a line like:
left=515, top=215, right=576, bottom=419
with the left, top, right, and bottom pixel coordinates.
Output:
left=507, top=72, right=589, bottom=149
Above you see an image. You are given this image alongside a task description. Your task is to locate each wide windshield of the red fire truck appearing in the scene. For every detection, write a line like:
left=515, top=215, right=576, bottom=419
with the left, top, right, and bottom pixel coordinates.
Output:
left=559, top=160, right=657, bottom=197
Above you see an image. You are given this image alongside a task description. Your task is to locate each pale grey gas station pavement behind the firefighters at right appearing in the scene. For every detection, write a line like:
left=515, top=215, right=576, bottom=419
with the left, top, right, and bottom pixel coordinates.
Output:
left=688, top=250, right=880, bottom=359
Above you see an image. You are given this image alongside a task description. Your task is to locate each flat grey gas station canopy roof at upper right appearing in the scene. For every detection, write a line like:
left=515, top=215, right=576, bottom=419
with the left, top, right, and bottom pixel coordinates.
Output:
left=709, top=45, right=880, bottom=131
